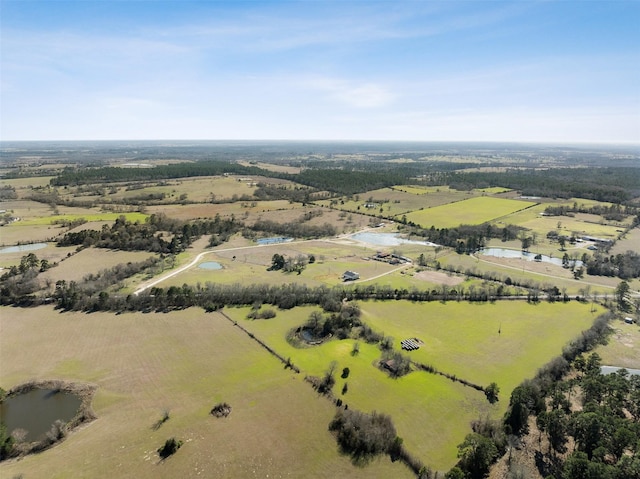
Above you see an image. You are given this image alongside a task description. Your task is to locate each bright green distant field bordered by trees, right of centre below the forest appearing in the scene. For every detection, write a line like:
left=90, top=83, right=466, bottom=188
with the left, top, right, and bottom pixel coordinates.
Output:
left=407, top=196, right=535, bottom=228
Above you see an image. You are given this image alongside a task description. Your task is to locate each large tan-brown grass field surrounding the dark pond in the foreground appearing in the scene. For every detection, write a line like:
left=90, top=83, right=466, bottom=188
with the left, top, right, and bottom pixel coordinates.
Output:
left=0, top=307, right=414, bottom=479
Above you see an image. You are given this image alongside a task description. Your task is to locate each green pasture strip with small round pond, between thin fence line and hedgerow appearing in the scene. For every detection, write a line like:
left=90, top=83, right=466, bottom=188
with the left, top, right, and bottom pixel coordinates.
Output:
left=225, top=307, right=496, bottom=471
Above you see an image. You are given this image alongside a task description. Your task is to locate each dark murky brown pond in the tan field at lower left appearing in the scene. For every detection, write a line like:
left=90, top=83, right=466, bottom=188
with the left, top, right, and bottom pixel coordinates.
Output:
left=0, top=389, right=82, bottom=442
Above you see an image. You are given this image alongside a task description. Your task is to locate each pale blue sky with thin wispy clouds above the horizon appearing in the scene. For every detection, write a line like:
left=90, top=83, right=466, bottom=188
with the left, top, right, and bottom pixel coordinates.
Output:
left=0, top=0, right=640, bottom=143
